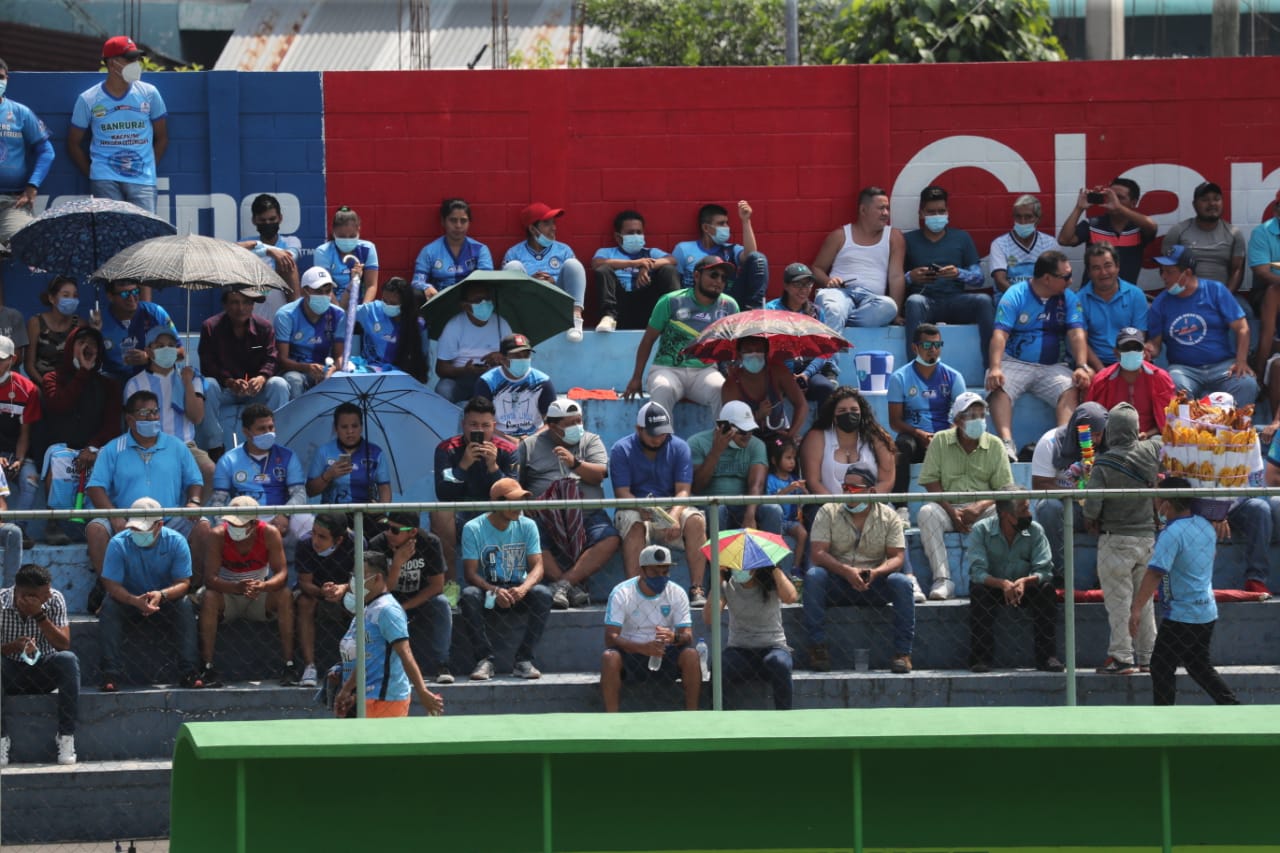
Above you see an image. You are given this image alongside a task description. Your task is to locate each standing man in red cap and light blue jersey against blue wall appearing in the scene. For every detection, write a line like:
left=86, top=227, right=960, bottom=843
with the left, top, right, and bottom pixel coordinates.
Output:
left=67, top=36, right=169, bottom=213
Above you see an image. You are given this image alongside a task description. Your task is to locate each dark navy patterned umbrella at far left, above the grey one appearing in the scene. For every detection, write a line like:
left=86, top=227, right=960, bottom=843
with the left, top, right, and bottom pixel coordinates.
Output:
left=9, top=196, right=178, bottom=280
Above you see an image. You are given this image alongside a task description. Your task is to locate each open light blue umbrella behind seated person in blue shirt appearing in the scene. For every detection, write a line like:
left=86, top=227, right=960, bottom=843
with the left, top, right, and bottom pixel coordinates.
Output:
left=275, top=370, right=462, bottom=497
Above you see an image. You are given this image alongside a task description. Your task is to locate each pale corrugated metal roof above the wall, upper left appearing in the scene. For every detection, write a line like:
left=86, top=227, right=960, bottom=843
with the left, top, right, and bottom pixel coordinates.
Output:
left=215, top=0, right=602, bottom=70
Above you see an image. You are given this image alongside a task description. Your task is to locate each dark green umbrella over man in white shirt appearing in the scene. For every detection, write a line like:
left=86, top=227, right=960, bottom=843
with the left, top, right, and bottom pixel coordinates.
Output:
left=422, top=270, right=573, bottom=350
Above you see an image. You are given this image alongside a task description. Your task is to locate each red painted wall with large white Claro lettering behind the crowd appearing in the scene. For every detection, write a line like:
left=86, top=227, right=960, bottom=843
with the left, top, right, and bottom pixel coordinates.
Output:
left=324, top=58, right=1280, bottom=302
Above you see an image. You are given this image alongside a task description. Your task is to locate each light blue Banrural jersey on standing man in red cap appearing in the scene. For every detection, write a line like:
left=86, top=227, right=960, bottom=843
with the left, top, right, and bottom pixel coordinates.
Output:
left=72, top=81, right=166, bottom=186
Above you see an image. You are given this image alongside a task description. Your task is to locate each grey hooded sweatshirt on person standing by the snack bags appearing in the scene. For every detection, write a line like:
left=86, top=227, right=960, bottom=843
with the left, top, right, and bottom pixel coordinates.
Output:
left=1084, top=403, right=1160, bottom=537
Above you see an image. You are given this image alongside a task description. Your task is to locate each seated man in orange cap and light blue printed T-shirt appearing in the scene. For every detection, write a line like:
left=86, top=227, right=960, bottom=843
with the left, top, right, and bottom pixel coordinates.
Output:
left=458, top=478, right=552, bottom=681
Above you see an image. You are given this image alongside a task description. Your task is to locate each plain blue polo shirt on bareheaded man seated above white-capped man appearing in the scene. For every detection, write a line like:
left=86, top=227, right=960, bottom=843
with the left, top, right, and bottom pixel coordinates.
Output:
left=84, top=432, right=205, bottom=508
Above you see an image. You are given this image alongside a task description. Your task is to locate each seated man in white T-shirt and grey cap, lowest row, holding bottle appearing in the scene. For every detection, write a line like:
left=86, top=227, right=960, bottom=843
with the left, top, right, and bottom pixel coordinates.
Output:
left=600, top=546, right=703, bottom=712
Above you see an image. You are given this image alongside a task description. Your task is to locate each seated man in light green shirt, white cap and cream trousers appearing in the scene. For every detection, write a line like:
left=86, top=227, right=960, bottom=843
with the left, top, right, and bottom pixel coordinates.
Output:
left=916, top=391, right=1014, bottom=601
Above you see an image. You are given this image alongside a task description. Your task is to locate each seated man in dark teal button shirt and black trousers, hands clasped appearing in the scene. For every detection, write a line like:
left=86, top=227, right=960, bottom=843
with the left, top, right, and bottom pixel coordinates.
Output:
left=965, top=496, right=1066, bottom=672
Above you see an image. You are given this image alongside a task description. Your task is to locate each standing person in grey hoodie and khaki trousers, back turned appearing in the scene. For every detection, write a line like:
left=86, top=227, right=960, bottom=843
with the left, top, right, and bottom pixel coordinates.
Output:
left=1084, top=402, right=1160, bottom=675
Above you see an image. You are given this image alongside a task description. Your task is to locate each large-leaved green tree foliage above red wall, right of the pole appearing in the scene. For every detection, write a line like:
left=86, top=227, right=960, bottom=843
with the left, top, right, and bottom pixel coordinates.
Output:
left=822, top=0, right=1066, bottom=64
